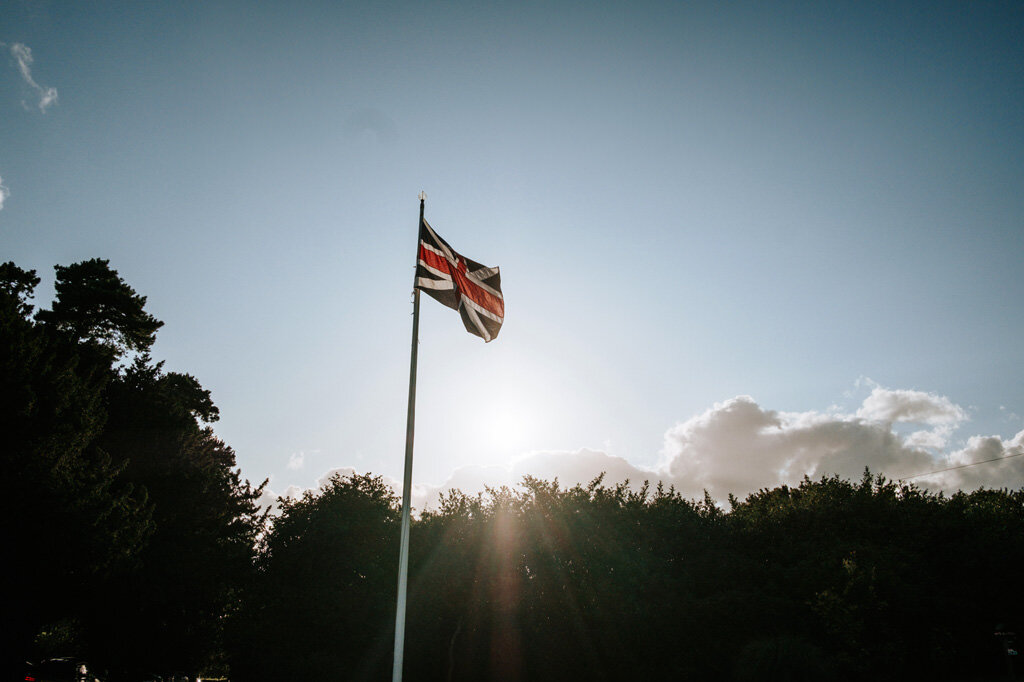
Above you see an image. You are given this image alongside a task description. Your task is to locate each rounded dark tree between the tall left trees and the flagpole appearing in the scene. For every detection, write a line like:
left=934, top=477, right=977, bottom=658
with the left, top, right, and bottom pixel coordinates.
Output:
left=231, top=474, right=399, bottom=681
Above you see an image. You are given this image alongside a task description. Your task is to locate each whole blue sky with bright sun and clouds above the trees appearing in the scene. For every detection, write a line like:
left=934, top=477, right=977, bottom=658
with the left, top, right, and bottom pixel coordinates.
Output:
left=0, top=0, right=1024, bottom=509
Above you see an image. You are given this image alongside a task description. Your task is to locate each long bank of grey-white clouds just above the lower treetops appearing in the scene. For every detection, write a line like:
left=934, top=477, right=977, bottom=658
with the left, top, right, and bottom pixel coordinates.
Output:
left=270, top=384, right=1024, bottom=510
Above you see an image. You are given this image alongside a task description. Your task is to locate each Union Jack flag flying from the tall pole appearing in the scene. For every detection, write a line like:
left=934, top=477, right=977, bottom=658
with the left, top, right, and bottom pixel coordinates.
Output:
left=416, top=218, right=505, bottom=341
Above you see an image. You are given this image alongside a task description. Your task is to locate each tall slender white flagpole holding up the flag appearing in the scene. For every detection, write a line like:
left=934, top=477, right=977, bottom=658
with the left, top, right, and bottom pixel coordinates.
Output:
left=391, top=191, right=427, bottom=682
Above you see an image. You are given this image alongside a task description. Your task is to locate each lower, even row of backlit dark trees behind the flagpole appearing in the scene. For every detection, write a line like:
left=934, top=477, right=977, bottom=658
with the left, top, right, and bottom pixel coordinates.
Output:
left=232, top=473, right=1024, bottom=680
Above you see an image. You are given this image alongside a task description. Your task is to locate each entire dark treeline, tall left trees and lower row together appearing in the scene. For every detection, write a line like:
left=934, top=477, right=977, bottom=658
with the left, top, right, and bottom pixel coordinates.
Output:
left=0, top=260, right=1024, bottom=682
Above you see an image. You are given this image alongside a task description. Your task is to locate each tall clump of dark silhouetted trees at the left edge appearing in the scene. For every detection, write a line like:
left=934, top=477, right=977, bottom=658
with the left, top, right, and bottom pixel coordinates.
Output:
left=0, top=259, right=262, bottom=679
